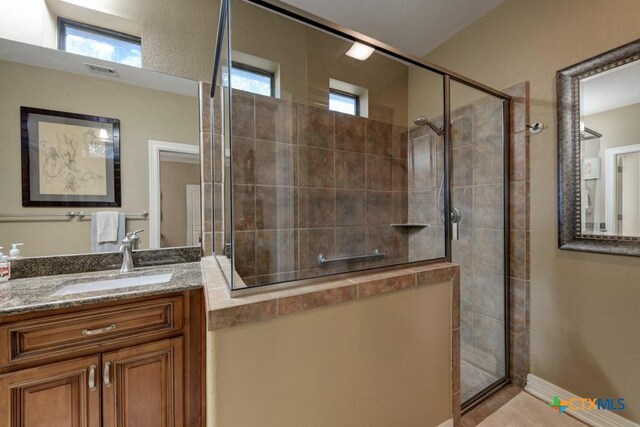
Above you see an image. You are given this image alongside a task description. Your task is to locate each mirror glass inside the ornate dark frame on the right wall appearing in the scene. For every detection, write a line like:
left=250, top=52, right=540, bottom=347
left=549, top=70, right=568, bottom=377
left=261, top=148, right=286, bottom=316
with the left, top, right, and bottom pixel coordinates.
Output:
left=580, top=61, right=640, bottom=236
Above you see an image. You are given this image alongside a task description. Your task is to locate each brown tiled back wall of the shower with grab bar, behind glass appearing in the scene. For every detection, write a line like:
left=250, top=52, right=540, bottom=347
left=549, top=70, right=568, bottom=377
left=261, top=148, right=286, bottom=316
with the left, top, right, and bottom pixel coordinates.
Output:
left=232, top=91, right=412, bottom=285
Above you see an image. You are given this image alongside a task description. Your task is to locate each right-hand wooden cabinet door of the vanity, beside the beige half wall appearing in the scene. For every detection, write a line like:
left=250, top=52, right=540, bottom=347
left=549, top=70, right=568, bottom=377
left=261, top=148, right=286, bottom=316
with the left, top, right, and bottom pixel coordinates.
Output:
left=102, top=337, right=184, bottom=427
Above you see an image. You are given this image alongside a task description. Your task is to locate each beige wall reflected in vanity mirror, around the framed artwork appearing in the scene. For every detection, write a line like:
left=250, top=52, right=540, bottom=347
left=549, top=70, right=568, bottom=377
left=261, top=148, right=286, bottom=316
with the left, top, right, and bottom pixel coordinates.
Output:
left=0, top=61, right=198, bottom=256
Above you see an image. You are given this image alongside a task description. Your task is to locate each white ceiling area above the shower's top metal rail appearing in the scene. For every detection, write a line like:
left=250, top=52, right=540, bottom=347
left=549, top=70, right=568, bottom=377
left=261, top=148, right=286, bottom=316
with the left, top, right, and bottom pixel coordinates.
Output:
left=284, top=0, right=504, bottom=56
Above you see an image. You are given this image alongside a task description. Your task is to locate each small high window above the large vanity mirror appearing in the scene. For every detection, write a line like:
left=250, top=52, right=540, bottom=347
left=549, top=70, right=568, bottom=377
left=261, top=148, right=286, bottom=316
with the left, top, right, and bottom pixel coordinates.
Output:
left=58, top=18, right=142, bottom=67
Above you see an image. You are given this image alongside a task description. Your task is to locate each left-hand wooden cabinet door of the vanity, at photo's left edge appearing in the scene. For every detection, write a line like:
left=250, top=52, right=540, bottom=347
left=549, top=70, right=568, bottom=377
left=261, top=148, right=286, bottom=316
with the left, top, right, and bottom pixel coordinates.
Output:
left=0, top=356, right=100, bottom=427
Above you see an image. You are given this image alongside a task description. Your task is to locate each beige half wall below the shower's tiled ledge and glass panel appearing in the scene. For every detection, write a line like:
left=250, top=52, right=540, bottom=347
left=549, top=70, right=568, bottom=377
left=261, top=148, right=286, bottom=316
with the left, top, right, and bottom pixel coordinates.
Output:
left=207, top=282, right=451, bottom=427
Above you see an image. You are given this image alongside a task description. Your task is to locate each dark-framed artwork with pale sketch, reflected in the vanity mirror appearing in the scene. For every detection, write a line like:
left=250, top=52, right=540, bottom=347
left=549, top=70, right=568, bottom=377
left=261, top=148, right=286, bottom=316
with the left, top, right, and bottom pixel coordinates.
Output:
left=20, top=107, right=121, bottom=207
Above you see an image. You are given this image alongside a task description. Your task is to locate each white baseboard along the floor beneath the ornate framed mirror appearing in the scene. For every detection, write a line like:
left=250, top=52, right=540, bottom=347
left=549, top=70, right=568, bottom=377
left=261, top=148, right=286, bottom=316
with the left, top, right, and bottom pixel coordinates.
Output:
left=524, top=374, right=640, bottom=427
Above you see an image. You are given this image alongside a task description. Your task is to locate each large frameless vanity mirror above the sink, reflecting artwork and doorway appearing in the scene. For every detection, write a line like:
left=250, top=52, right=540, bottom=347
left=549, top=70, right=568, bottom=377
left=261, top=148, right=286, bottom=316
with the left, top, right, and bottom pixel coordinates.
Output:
left=0, top=40, right=200, bottom=256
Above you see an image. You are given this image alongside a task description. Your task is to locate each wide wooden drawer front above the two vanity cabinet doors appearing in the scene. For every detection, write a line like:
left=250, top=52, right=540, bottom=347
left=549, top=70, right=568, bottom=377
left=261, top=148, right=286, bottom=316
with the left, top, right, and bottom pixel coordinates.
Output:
left=0, top=296, right=183, bottom=366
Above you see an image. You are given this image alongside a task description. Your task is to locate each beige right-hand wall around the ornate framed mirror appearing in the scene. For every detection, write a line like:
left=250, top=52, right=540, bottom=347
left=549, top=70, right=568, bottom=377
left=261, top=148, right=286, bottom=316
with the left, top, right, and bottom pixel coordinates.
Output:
left=427, top=0, right=640, bottom=422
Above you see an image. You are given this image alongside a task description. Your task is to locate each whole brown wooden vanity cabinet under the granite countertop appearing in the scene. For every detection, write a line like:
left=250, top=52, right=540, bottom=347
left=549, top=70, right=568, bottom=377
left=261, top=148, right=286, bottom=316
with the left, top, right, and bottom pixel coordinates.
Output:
left=0, top=291, right=204, bottom=427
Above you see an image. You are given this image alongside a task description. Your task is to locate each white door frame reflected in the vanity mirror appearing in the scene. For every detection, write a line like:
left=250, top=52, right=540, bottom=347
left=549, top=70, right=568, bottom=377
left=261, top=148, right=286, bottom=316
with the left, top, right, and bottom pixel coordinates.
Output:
left=149, top=139, right=200, bottom=249
